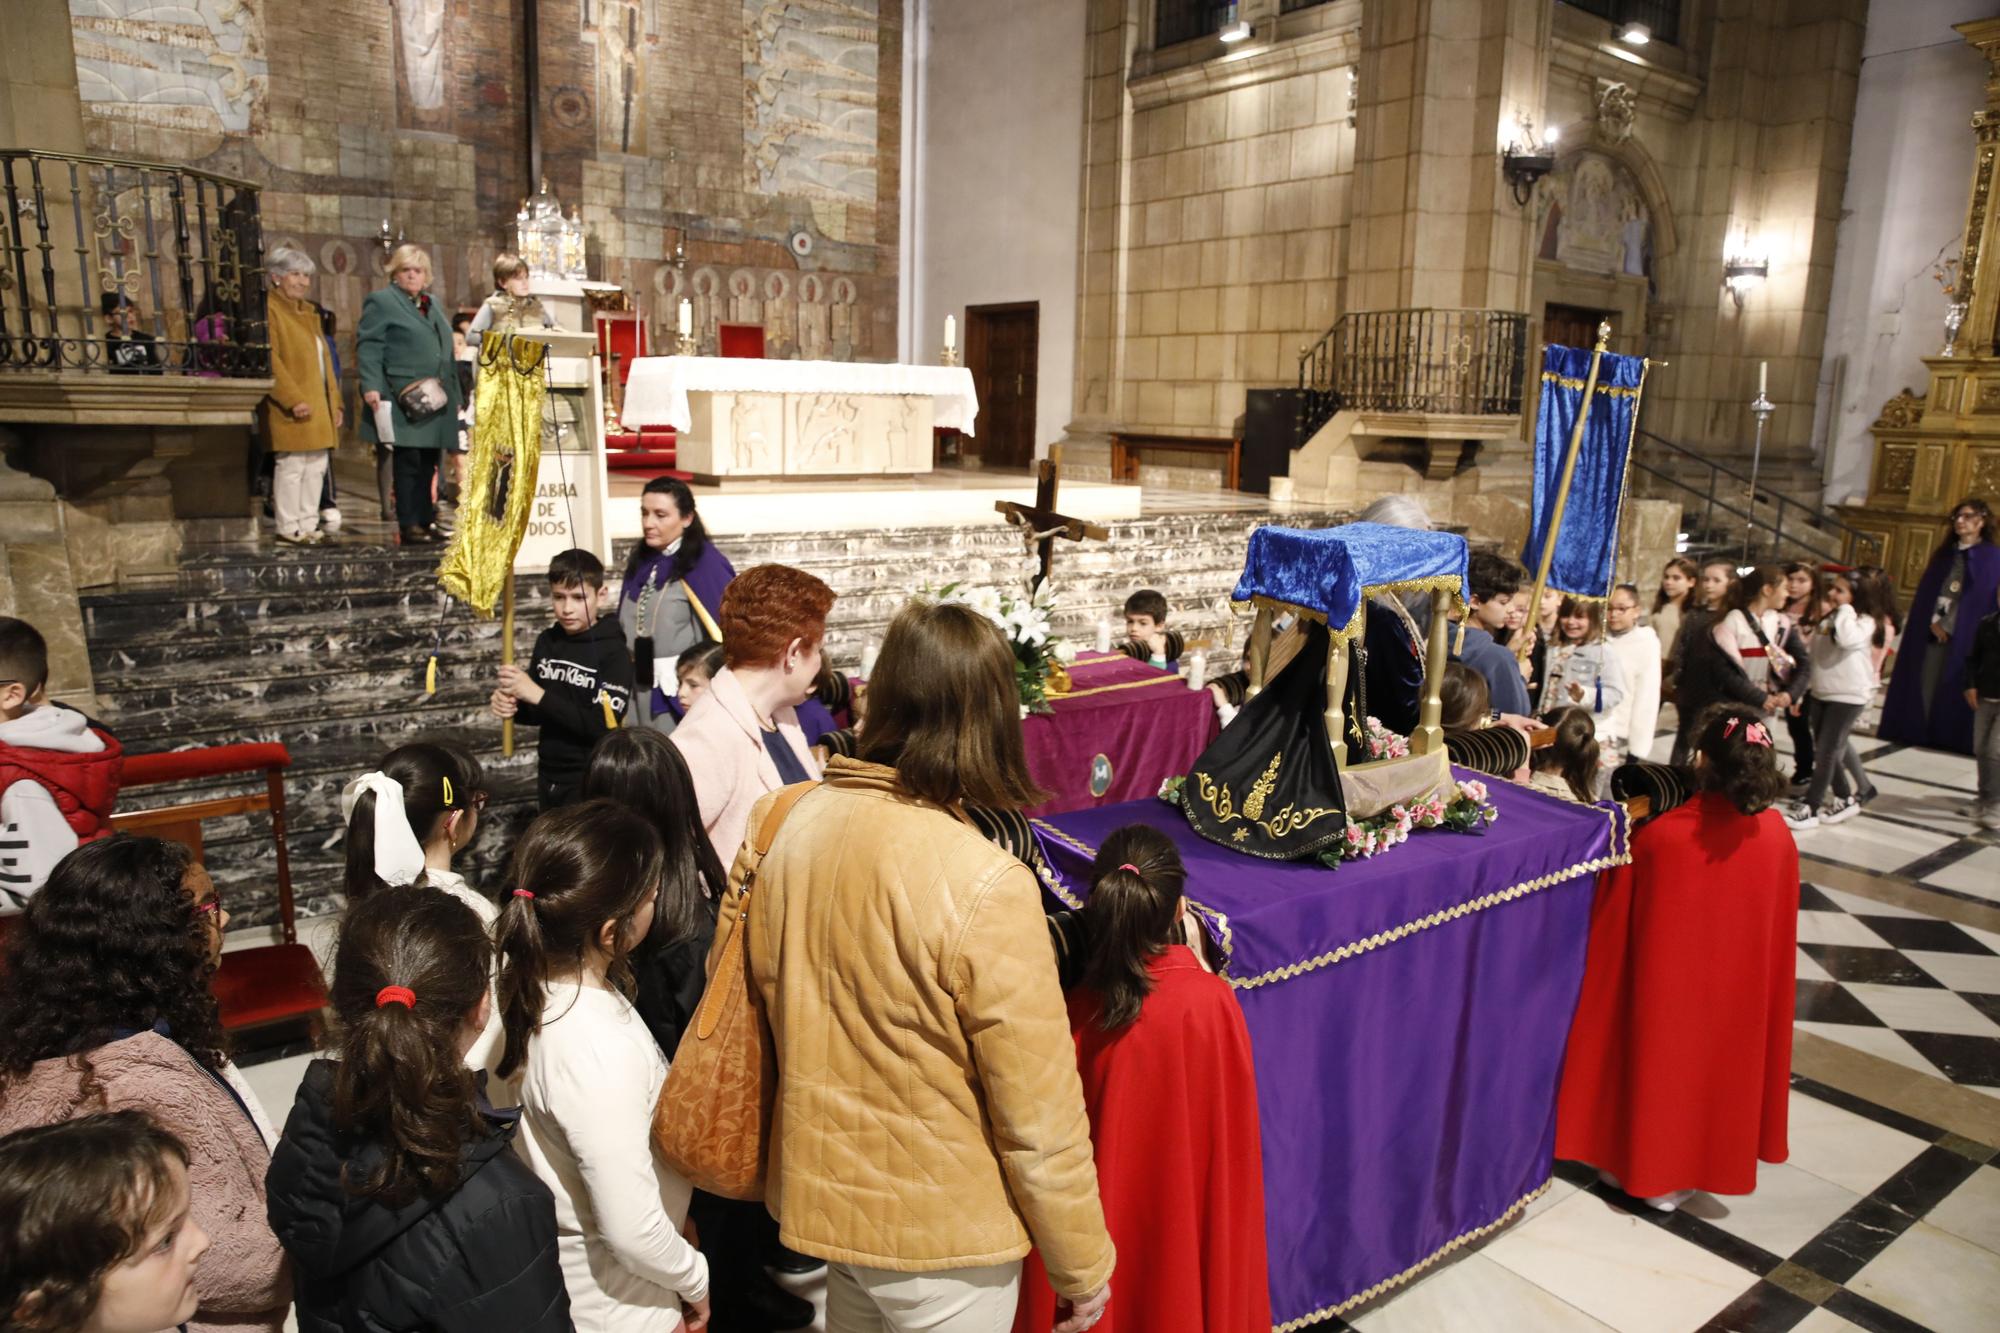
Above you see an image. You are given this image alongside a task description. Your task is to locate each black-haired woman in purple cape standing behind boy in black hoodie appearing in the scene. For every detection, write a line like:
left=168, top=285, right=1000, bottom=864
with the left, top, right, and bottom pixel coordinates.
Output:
left=618, top=476, right=736, bottom=731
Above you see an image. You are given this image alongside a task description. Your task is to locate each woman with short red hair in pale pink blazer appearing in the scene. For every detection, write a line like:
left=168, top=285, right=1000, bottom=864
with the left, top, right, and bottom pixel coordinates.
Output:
left=672, top=564, right=834, bottom=865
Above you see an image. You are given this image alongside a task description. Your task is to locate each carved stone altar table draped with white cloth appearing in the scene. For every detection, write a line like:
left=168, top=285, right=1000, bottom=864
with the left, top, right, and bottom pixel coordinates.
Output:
left=622, top=356, right=980, bottom=482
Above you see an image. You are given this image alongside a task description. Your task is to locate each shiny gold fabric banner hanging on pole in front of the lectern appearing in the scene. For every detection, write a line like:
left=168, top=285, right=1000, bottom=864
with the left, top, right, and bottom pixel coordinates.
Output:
left=438, top=332, right=548, bottom=616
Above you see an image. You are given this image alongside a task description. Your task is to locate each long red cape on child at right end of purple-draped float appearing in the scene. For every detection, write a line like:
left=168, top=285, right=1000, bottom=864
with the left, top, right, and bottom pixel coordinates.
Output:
left=1556, top=793, right=1798, bottom=1197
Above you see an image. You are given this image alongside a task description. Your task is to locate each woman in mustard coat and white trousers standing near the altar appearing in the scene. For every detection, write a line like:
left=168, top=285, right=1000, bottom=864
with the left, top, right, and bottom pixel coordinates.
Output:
left=262, top=246, right=344, bottom=546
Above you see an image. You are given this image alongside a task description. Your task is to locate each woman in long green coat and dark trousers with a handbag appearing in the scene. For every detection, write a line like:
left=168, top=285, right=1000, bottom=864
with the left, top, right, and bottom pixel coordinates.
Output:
left=356, top=246, right=460, bottom=546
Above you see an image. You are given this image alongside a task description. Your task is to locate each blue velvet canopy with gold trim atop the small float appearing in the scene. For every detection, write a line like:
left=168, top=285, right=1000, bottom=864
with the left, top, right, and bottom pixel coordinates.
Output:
left=1234, top=522, right=1466, bottom=638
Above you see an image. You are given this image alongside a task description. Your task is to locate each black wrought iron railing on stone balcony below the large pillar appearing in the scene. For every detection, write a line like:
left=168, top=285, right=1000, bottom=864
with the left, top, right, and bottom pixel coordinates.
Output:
left=1298, top=310, right=1528, bottom=442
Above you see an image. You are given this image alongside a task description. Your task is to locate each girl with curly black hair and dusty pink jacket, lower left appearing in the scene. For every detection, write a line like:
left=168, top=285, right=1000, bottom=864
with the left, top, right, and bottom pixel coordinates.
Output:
left=0, top=835, right=292, bottom=1333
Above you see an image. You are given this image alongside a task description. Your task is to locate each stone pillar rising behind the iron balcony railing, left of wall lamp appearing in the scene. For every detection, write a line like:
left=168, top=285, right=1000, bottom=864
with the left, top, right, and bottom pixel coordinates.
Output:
left=1344, top=0, right=1552, bottom=310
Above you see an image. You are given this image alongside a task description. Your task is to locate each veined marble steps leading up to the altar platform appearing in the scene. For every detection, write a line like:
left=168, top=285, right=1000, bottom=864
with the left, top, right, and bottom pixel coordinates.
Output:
left=84, top=512, right=1344, bottom=925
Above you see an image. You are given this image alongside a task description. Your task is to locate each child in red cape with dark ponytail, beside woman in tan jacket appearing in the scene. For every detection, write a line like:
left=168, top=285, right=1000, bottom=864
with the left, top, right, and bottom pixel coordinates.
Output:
left=1014, top=825, right=1270, bottom=1333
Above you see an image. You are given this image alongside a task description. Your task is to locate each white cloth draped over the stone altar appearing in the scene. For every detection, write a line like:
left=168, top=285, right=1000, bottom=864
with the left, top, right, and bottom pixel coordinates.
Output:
left=622, top=356, right=980, bottom=434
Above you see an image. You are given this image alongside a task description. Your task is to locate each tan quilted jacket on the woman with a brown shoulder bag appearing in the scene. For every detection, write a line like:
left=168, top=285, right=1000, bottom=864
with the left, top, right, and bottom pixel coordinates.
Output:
left=744, top=759, right=1114, bottom=1297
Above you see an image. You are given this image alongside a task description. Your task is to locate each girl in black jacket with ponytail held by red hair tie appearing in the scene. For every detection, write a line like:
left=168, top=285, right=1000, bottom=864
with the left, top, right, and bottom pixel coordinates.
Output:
left=266, top=887, right=570, bottom=1333
